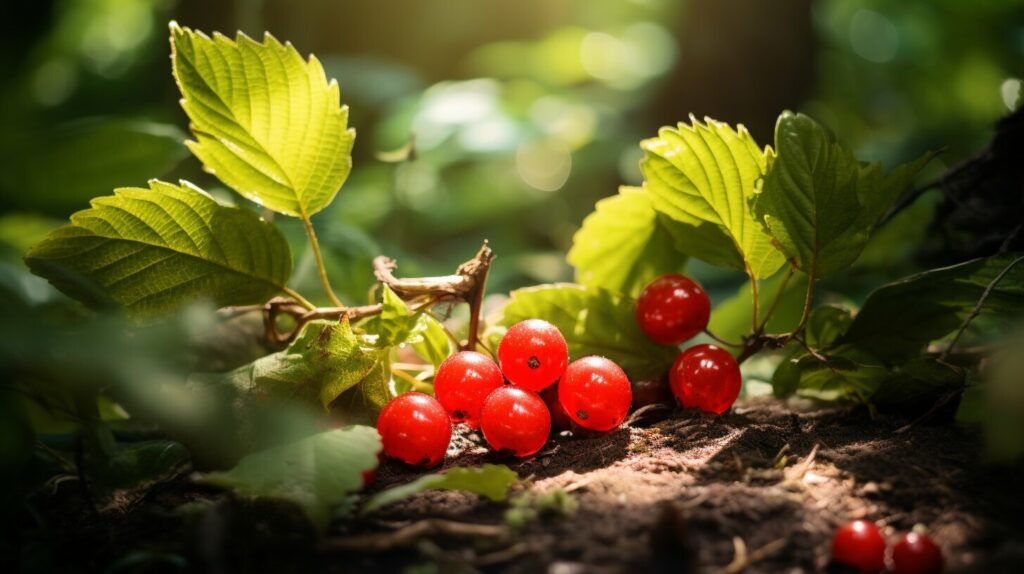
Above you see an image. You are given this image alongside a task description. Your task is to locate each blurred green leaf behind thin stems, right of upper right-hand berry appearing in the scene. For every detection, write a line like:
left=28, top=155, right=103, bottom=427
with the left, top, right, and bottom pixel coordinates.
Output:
left=708, top=272, right=807, bottom=343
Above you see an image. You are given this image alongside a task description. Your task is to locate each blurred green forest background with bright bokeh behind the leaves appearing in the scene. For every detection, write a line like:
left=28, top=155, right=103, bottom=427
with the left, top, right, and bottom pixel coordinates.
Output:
left=0, top=0, right=1024, bottom=303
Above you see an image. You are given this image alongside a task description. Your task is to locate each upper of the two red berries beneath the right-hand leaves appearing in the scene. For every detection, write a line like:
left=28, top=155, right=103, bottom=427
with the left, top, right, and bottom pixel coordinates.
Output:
left=637, top=274, right=711, bottom=345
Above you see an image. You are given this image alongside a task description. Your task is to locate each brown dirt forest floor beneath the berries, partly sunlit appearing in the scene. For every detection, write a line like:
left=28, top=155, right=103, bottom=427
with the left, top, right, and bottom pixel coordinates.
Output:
left=19, top=400, right=1024, bottom=574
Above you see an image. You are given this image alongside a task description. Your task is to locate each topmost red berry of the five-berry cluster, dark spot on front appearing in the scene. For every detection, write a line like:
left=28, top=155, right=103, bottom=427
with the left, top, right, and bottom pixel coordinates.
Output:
left=498, top=319, right=569, bottom=393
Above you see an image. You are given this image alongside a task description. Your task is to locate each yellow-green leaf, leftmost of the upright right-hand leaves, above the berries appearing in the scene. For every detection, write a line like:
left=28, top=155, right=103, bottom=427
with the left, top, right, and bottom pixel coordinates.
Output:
left=566, top=186, right=686, bottom=297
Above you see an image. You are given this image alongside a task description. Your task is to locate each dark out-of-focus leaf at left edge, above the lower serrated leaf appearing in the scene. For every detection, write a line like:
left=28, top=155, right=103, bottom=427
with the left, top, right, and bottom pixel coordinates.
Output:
left=0, top=119, right=187, bottom=213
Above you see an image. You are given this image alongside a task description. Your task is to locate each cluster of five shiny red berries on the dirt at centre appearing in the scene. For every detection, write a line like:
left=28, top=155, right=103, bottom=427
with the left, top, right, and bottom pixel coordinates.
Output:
left=377, top=319, right=632, bottom=467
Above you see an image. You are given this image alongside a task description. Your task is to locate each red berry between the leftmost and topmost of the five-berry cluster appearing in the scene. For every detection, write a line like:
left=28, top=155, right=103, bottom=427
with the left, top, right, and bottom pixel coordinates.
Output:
left=434, top=351, right=505, bottom=429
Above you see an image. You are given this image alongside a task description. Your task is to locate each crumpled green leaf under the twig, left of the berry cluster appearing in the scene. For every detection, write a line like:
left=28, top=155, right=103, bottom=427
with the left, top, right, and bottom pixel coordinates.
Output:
left=190, top=320, right=384, bottom=408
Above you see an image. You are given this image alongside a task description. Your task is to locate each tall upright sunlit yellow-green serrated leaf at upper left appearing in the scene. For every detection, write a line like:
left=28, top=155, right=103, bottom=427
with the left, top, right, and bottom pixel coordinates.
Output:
left=171, top=23, right=355, bottom=218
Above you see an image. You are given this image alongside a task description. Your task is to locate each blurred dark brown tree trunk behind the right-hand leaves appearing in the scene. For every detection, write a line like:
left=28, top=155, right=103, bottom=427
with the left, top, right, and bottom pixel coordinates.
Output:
left=648, top=0, right=814, bottom=145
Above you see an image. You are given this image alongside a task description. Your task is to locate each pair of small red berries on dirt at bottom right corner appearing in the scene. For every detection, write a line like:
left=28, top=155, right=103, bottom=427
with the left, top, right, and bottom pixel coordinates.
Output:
left=831, top=520, right=943, bottom=574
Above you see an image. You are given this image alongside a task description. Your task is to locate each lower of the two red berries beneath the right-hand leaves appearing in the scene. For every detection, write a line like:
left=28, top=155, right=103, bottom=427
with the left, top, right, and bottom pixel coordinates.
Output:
left=669, top=344, right=743, bottom=414
